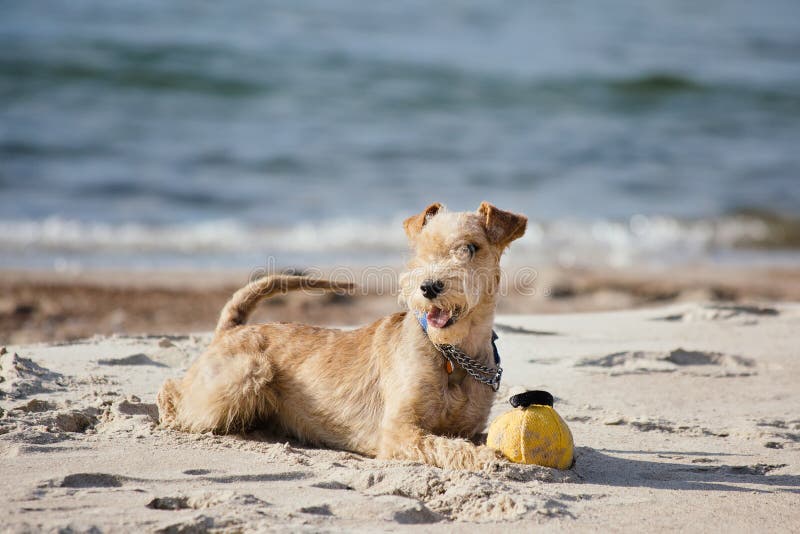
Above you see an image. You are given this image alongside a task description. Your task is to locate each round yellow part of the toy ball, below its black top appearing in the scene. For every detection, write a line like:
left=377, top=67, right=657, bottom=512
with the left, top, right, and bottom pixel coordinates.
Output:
left=486, top=394, right=574, bottom=469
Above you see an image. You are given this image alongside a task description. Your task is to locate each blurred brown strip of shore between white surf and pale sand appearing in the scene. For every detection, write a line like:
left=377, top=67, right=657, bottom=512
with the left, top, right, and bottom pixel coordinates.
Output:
left=0, top=266, right=800, bottom=344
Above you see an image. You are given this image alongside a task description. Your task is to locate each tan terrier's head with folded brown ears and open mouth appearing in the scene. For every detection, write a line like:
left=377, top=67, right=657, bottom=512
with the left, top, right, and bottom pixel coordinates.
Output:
left=400, top=202, right=528, bottom=345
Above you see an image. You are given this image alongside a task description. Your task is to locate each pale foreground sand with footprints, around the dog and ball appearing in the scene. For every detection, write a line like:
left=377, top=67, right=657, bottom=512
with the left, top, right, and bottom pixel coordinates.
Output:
left=0, top=302, right=800, bottom=532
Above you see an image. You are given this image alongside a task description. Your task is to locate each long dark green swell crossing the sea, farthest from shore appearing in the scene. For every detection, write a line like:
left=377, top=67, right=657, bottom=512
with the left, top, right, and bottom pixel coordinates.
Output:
left=0, top=40, right=800, bottom=112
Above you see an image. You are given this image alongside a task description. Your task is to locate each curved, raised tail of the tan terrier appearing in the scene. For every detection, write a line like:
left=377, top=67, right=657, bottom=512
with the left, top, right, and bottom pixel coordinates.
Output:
left=216, top=274, right=355, bottom=334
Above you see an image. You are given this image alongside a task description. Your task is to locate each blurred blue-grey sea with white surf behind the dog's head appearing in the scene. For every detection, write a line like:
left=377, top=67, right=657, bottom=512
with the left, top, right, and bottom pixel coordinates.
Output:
left=0, top=0, right=800, bottom=268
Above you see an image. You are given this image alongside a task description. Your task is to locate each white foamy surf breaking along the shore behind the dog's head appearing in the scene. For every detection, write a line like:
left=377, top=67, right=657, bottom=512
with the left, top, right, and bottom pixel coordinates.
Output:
left=0, top=213, right=800, bottom=267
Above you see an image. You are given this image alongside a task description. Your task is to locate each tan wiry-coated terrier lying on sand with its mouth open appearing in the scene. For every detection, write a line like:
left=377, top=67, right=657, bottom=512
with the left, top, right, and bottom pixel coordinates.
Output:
left=157, top=202, right=527, bottom=471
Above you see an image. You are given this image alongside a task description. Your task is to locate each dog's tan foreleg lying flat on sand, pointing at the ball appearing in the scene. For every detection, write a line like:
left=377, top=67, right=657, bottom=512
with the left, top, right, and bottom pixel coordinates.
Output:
left=378, top=425, right=502, bottom=471
